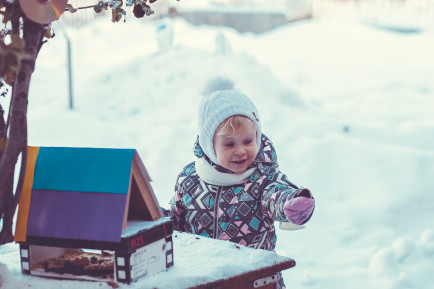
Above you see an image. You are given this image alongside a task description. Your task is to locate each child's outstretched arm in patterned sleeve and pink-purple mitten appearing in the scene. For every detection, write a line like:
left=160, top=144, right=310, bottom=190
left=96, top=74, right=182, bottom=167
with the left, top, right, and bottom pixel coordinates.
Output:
left=262, top=172, right=315, bottom=225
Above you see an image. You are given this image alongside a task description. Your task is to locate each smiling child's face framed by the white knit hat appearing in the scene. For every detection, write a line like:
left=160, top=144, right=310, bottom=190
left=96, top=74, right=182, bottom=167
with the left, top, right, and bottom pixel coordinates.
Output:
left=214, top=123, right=258, bottom=173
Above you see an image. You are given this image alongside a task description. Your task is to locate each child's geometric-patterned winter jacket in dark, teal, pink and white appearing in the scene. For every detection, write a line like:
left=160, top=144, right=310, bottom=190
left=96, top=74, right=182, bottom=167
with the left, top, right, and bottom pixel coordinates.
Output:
left=170, top=135, right=310, bottom=250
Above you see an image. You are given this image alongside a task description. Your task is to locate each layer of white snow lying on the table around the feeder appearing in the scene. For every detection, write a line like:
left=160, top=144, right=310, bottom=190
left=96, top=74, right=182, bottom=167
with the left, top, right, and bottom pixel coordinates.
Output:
left=0, top=232, right=290, bottom=289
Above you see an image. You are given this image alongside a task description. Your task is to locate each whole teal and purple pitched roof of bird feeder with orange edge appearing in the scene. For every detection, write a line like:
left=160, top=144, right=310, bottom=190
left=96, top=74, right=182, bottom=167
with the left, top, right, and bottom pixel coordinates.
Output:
left=15, top=147, right=163, bottom=242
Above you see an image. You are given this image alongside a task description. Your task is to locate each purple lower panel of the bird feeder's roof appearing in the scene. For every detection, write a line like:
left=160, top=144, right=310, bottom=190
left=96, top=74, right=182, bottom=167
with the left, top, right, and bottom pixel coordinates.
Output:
left=27, top=190, right=127, bottom=242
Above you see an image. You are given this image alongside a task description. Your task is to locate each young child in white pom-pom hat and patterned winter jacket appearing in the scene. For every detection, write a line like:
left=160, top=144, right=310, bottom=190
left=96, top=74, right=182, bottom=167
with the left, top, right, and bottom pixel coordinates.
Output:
left=170, top=78, right=315, bottom=288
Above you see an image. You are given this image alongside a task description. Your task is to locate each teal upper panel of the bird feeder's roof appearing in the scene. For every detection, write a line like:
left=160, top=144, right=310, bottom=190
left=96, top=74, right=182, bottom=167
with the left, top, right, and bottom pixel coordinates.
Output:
left=33, top=147, right=135, bottom=194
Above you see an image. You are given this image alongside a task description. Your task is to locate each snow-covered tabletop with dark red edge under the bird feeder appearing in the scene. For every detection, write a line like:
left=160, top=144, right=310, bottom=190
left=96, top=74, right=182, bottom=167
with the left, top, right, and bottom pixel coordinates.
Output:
left=0, top=231, right=295, bottom=289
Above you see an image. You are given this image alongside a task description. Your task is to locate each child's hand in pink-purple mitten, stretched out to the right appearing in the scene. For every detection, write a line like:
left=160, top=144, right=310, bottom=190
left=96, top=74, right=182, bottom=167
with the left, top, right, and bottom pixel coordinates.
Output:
left=283, top=189, right=315, bottom=225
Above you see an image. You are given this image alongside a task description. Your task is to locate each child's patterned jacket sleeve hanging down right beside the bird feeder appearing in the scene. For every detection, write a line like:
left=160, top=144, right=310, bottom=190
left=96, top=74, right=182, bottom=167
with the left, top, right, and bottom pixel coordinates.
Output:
left=169, top=175, right=191, bottom=233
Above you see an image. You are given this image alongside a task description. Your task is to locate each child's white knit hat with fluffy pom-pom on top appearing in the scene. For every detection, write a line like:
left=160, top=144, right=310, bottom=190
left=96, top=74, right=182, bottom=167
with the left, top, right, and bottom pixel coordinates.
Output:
left=199, top=77, right=261, bottom=164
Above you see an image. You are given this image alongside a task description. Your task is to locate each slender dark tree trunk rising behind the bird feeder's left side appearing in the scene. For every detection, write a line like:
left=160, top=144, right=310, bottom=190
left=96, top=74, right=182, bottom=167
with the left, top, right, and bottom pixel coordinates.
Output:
left=0, top=17, right=46, bottom=245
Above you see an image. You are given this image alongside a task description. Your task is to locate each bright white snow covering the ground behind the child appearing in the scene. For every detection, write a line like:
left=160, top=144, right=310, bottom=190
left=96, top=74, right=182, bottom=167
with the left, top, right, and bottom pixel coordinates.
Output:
left=0, top=4, right=434, bottom=289
